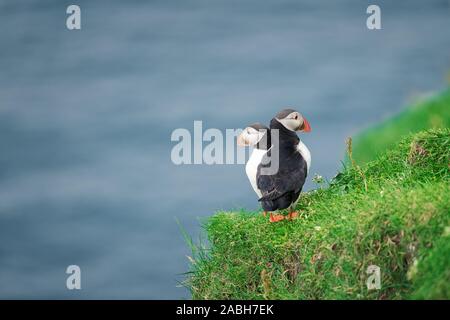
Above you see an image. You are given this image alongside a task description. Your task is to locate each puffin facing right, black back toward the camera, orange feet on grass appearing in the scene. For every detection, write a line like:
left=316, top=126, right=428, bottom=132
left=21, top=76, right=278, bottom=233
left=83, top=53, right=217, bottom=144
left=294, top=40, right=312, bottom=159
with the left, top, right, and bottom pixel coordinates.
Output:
left=256, top=109, right=311, bottom=222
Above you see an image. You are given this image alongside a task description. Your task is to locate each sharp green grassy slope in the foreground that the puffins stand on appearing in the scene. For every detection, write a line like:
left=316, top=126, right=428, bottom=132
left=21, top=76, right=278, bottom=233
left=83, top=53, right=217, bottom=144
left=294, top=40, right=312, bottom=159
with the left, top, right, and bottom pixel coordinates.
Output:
left=187, top=95, right=450, bottom=299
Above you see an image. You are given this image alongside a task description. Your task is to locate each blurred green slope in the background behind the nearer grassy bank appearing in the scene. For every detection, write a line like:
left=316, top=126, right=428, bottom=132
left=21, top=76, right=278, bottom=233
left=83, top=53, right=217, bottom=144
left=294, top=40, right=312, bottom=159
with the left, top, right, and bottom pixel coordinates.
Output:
left=353, top=89, right=450, bottom=163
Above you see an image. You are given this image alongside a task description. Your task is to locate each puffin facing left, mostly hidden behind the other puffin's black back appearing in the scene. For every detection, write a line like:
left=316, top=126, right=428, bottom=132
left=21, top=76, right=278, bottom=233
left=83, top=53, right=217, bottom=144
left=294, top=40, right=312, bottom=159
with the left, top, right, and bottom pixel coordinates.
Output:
left=237, top=122, right=271, bottom=198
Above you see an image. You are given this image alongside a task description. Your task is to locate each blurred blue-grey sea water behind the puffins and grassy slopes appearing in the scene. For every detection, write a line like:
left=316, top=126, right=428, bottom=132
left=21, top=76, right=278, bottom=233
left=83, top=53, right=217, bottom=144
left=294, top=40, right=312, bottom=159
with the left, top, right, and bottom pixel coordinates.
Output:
left=0, top=0, right=450, bottom=299
